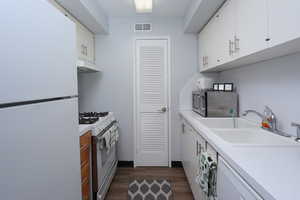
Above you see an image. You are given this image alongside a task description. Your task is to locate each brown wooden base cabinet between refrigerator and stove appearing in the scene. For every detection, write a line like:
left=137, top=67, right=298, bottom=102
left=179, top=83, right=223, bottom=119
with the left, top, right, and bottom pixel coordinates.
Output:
left=80, top=131, right=92, bottom=200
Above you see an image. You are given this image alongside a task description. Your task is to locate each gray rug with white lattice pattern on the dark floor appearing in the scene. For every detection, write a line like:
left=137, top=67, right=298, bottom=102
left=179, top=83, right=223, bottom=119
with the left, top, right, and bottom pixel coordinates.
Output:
left=128, top=179, right=173, bottom=200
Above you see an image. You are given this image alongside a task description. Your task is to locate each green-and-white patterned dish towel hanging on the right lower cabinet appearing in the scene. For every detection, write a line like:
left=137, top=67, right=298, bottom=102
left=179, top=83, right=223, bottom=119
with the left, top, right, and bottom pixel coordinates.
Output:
left=195, top=152, right=217, bottom=200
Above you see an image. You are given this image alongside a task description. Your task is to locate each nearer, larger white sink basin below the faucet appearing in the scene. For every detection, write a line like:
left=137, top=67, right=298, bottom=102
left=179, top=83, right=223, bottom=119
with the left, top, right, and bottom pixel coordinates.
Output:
left=213, top=129, right=300, bottom=147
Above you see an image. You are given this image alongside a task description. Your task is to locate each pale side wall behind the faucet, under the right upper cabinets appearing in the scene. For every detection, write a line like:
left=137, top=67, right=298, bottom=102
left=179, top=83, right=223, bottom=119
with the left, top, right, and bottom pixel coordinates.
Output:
left=220, top=54, right=300, bottom=135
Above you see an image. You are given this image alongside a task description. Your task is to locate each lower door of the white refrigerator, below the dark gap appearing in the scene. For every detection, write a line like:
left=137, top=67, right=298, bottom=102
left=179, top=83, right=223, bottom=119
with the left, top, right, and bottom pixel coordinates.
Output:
left=0, top=98, right=81, bottom=200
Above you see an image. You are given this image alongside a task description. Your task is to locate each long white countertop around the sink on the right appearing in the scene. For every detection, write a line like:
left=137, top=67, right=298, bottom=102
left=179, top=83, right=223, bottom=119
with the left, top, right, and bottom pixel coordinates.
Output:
left=180, top=111, right=300, bottom=200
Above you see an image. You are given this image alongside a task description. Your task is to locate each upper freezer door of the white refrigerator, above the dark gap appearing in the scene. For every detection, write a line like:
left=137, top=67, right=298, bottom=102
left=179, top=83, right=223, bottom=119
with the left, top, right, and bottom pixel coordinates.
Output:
left=0, top=0, right=77, bottom=104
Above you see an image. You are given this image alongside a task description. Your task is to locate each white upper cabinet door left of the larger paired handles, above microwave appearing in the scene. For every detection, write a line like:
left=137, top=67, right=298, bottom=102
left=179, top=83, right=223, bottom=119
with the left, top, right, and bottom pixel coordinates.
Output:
left=214, top=0, right=236, bottom=65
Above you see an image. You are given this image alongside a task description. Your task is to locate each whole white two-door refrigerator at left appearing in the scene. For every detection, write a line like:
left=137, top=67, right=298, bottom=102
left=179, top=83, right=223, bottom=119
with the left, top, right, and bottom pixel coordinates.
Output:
left=0, top=0, right=81, bottom=200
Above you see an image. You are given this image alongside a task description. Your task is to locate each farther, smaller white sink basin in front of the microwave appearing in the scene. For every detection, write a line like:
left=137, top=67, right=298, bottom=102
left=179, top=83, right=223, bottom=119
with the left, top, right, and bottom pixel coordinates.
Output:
left=200, top=118, right=260, bottom=129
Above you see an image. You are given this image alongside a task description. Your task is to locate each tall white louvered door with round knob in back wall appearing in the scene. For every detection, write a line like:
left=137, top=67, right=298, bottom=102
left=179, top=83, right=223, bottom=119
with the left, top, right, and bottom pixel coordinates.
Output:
left=135, top=40, right=169, bottom=166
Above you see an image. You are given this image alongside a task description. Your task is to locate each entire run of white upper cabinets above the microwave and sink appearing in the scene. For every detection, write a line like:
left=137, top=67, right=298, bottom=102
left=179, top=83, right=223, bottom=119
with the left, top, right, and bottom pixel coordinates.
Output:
left=199, top=0, right=300, bottom=72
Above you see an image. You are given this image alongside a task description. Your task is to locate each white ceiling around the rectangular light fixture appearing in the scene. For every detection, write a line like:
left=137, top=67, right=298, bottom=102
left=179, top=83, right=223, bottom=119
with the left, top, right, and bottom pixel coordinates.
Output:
left=97, top=0, right=193, bottom=17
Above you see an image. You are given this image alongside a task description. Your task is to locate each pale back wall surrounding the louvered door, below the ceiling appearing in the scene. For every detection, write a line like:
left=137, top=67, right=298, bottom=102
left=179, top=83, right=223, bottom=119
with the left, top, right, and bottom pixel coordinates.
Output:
left=79, top=18, right=197, bottom=160
